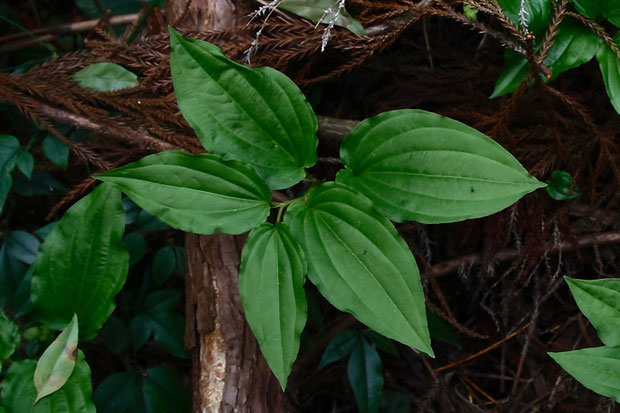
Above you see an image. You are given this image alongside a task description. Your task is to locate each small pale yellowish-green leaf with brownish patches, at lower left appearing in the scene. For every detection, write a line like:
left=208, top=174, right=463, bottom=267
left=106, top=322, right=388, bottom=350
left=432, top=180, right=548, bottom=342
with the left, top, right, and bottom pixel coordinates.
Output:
left=34, top=315, right=78, bottom=404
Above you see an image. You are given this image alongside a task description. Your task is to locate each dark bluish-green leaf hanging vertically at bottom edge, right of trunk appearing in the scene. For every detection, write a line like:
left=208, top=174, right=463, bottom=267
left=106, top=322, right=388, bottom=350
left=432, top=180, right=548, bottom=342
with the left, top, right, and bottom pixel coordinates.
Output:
left=347, top=340, right=383, bottom=413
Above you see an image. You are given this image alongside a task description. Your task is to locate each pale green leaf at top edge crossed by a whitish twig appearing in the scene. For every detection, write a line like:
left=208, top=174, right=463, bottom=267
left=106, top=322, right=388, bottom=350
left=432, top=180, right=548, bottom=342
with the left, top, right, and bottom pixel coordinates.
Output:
left=278, top=0, right=366, bottom=36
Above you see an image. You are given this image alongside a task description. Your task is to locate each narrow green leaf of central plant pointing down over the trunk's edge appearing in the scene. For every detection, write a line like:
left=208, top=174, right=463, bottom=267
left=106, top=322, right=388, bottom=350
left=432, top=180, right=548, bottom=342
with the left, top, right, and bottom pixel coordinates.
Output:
left=239, top=223, right=307, bottom=389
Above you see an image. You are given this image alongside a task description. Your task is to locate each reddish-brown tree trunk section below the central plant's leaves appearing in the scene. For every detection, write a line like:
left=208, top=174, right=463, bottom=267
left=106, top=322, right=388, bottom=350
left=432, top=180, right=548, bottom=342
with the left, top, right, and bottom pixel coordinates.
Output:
left=185, top=234, right=293, bottom=412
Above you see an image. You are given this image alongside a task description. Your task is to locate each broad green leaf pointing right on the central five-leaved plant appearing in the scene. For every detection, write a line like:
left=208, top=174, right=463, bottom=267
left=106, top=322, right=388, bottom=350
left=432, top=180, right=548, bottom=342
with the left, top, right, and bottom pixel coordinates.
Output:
left=336, top=110, right=545, bottom=224
